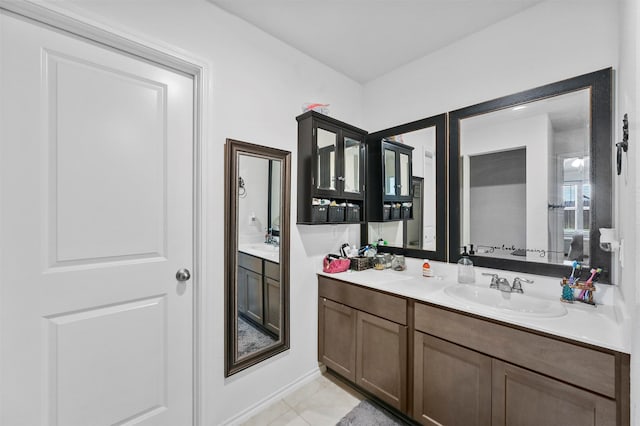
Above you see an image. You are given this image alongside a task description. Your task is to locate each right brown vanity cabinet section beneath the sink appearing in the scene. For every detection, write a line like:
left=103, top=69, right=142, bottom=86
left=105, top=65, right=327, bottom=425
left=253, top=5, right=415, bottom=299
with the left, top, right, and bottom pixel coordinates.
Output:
left=413, top=303, right=629, bottom=426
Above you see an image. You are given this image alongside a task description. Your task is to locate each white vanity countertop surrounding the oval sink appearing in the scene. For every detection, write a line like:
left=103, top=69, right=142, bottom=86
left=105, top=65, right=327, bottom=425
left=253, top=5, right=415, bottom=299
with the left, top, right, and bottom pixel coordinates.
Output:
left=318, top=259, right=631, bottom=353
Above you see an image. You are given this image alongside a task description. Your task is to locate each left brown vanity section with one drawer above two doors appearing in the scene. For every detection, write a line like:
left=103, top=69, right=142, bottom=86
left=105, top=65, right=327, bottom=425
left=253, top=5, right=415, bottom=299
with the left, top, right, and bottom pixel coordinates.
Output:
left=318, top=277, right=407, bottom=413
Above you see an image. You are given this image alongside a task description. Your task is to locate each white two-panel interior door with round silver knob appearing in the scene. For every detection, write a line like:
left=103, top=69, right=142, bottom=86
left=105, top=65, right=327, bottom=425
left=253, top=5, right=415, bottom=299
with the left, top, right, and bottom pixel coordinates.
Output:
left=0, top=14, right=194, bottom=426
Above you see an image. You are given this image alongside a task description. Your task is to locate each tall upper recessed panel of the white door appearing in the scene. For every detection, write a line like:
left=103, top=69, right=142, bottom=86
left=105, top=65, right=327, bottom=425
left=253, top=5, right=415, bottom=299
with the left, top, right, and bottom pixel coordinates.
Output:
left=44, top=51, right=168, bottom=266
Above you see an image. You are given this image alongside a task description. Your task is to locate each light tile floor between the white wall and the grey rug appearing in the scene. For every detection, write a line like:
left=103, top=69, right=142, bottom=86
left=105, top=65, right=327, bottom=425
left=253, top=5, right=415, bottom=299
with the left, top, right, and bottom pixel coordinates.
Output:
left=242, top=373, right=364, bottom=426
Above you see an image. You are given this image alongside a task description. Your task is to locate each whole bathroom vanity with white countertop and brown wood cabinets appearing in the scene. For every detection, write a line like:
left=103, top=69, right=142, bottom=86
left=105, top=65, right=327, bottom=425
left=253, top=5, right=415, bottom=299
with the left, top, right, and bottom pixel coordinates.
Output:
left=318, top=264, right=630, bottom=425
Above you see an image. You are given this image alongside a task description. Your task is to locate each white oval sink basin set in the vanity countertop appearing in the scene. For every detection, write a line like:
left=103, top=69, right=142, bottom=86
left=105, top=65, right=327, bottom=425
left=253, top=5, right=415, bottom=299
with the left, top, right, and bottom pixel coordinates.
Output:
left=444, top=284, right=567, bottom=318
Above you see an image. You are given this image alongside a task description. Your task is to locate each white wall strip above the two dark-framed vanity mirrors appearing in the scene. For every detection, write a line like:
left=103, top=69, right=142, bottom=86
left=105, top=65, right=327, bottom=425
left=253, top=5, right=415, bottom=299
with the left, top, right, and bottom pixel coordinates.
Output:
left=364, top=0, right=618, bottom=131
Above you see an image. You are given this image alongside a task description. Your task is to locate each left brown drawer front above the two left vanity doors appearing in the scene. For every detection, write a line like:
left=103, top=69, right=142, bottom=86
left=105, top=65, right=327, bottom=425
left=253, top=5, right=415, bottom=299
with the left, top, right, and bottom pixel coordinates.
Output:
left=318, top=276, right=407, bottom=325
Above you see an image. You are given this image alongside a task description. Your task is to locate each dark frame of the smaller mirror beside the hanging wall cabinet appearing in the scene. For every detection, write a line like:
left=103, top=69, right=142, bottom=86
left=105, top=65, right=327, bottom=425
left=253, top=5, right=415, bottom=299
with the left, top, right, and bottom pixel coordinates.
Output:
left=360, top=114, right=447, bottom=262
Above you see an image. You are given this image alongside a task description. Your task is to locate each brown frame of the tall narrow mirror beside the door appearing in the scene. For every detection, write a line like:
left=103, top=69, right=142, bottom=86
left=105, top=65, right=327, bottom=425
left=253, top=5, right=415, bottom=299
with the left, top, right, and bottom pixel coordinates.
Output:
left=224, top=139, right=291, bottom=377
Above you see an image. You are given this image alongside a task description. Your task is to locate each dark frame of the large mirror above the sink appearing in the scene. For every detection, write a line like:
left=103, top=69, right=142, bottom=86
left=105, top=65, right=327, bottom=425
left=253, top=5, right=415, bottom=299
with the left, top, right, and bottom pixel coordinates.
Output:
left=449, top=68, right=613, bottom=283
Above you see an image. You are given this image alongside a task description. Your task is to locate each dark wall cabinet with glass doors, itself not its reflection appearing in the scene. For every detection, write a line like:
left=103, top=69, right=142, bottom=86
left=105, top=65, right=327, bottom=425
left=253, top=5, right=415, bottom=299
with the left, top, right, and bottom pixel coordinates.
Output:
left=296, top=111, right=367, bottom=224
